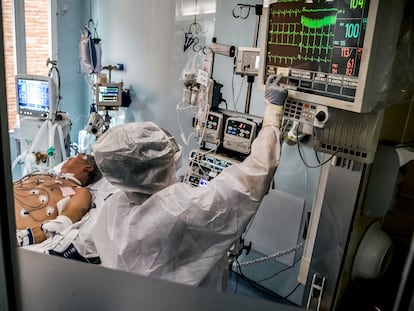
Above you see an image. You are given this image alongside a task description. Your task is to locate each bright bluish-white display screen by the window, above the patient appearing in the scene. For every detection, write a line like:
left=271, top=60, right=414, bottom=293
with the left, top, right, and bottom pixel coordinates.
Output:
left=16, top=77, right=49, bottom=116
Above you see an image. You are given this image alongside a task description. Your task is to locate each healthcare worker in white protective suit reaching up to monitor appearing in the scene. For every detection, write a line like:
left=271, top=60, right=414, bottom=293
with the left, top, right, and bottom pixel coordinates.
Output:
left=92, top=76, right=287, bottom=290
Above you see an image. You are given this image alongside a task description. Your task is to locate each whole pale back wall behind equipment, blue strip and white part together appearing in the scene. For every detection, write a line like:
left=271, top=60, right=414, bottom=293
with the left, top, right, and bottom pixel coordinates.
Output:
left=56, top=0, right=263, bottom=156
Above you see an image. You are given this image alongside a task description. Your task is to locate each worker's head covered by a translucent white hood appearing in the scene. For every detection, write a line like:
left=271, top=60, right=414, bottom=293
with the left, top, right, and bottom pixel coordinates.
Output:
left=92, top=122, right=181, bottom=194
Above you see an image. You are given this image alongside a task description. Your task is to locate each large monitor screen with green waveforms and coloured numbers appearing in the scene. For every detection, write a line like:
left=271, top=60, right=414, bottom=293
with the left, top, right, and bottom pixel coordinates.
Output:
left=265, top=0, right=369, bottom=101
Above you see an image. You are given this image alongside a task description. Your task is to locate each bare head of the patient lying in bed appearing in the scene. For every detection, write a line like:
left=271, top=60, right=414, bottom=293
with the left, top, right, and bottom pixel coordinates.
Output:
left=61, top=153, right=102, bottom=186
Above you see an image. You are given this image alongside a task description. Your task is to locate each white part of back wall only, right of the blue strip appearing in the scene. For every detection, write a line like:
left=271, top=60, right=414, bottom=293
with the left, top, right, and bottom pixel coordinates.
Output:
left=86, top=0, right=263, bottom=156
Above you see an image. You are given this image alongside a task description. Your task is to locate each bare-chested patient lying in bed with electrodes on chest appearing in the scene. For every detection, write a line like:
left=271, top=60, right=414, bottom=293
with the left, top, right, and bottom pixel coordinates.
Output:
left=13, top=154, right=102, bottom=246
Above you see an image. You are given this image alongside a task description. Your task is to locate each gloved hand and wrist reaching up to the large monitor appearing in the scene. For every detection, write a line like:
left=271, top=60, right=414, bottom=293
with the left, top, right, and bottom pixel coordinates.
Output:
left=263, top=75, right=288, bottom=128
